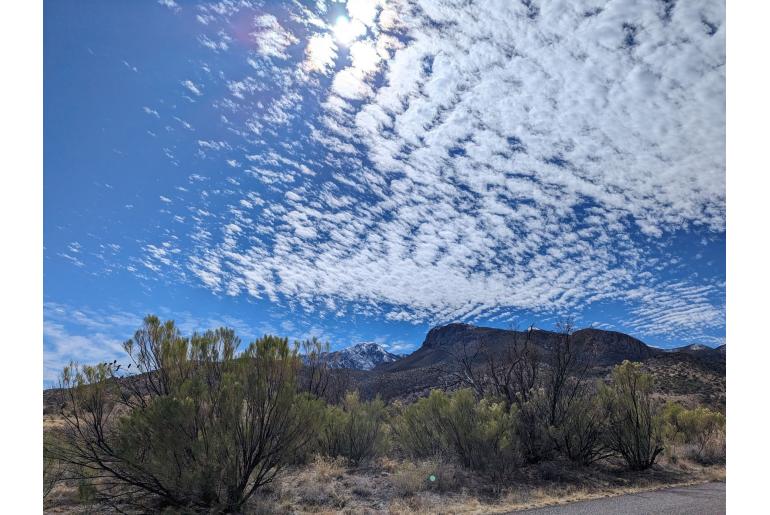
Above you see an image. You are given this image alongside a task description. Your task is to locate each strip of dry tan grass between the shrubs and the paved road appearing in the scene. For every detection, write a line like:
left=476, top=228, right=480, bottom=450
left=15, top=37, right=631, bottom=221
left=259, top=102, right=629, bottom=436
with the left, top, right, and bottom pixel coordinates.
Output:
left=237, top=458, right=725, bottom=515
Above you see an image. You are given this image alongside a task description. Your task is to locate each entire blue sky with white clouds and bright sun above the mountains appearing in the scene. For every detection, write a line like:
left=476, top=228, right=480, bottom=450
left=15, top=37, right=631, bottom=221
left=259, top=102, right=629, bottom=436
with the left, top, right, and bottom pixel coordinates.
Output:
left=43, top=0, right=725, bottom=384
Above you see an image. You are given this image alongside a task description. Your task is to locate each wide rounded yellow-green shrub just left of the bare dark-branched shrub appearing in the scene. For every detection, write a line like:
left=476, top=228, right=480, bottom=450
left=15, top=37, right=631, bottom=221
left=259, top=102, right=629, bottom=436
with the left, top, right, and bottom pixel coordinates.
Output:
left=394, top=389, right=521, bottom=482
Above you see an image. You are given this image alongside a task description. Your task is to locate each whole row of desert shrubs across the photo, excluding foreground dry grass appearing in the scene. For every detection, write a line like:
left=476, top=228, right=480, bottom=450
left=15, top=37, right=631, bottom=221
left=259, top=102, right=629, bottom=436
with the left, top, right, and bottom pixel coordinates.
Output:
left=44, top=316, right=725, bottom=512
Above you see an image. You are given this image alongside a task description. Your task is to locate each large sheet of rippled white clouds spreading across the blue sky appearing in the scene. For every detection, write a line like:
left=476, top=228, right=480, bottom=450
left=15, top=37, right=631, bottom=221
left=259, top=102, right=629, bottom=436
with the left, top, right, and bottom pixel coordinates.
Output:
left=45, top=0, right=725, bottom=362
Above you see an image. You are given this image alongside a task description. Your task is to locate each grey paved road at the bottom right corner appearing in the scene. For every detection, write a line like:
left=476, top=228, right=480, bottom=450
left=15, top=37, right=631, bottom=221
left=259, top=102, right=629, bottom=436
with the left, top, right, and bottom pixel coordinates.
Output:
left=517, top=483, right=725, bottom=515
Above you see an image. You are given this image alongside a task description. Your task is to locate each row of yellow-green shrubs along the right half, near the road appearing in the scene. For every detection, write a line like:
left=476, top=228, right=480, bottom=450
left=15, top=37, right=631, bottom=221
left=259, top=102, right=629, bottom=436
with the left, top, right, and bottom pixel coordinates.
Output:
left=391, top=361, right=724, bottom=481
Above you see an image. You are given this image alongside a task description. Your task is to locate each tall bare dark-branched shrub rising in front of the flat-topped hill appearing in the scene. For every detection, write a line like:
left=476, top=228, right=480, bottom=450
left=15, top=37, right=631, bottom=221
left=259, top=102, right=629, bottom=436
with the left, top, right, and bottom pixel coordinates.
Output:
left=444, top=319, right=607, bottom=464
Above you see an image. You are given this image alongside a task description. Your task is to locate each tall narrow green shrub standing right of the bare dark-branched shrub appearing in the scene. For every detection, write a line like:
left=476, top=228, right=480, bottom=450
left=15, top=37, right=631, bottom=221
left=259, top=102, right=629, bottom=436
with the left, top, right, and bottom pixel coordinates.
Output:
left=599, top=361, right=663, bottom=470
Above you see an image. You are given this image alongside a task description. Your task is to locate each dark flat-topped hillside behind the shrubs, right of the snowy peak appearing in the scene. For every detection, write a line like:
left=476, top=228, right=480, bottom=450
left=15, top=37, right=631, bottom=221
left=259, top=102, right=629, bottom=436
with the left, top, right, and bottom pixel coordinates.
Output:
left=354, top=324, right=725, bottom=407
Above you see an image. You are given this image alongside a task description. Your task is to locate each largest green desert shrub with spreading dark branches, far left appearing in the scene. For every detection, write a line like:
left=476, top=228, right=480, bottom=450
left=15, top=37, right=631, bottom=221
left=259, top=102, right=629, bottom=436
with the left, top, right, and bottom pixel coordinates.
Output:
left=48, top=316, right=322, bottom=512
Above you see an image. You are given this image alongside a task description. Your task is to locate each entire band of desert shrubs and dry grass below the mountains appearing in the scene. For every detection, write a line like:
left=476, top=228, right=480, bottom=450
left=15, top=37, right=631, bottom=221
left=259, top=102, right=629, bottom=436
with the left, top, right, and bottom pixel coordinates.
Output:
left=44, top=317, right=725, bottom=513
